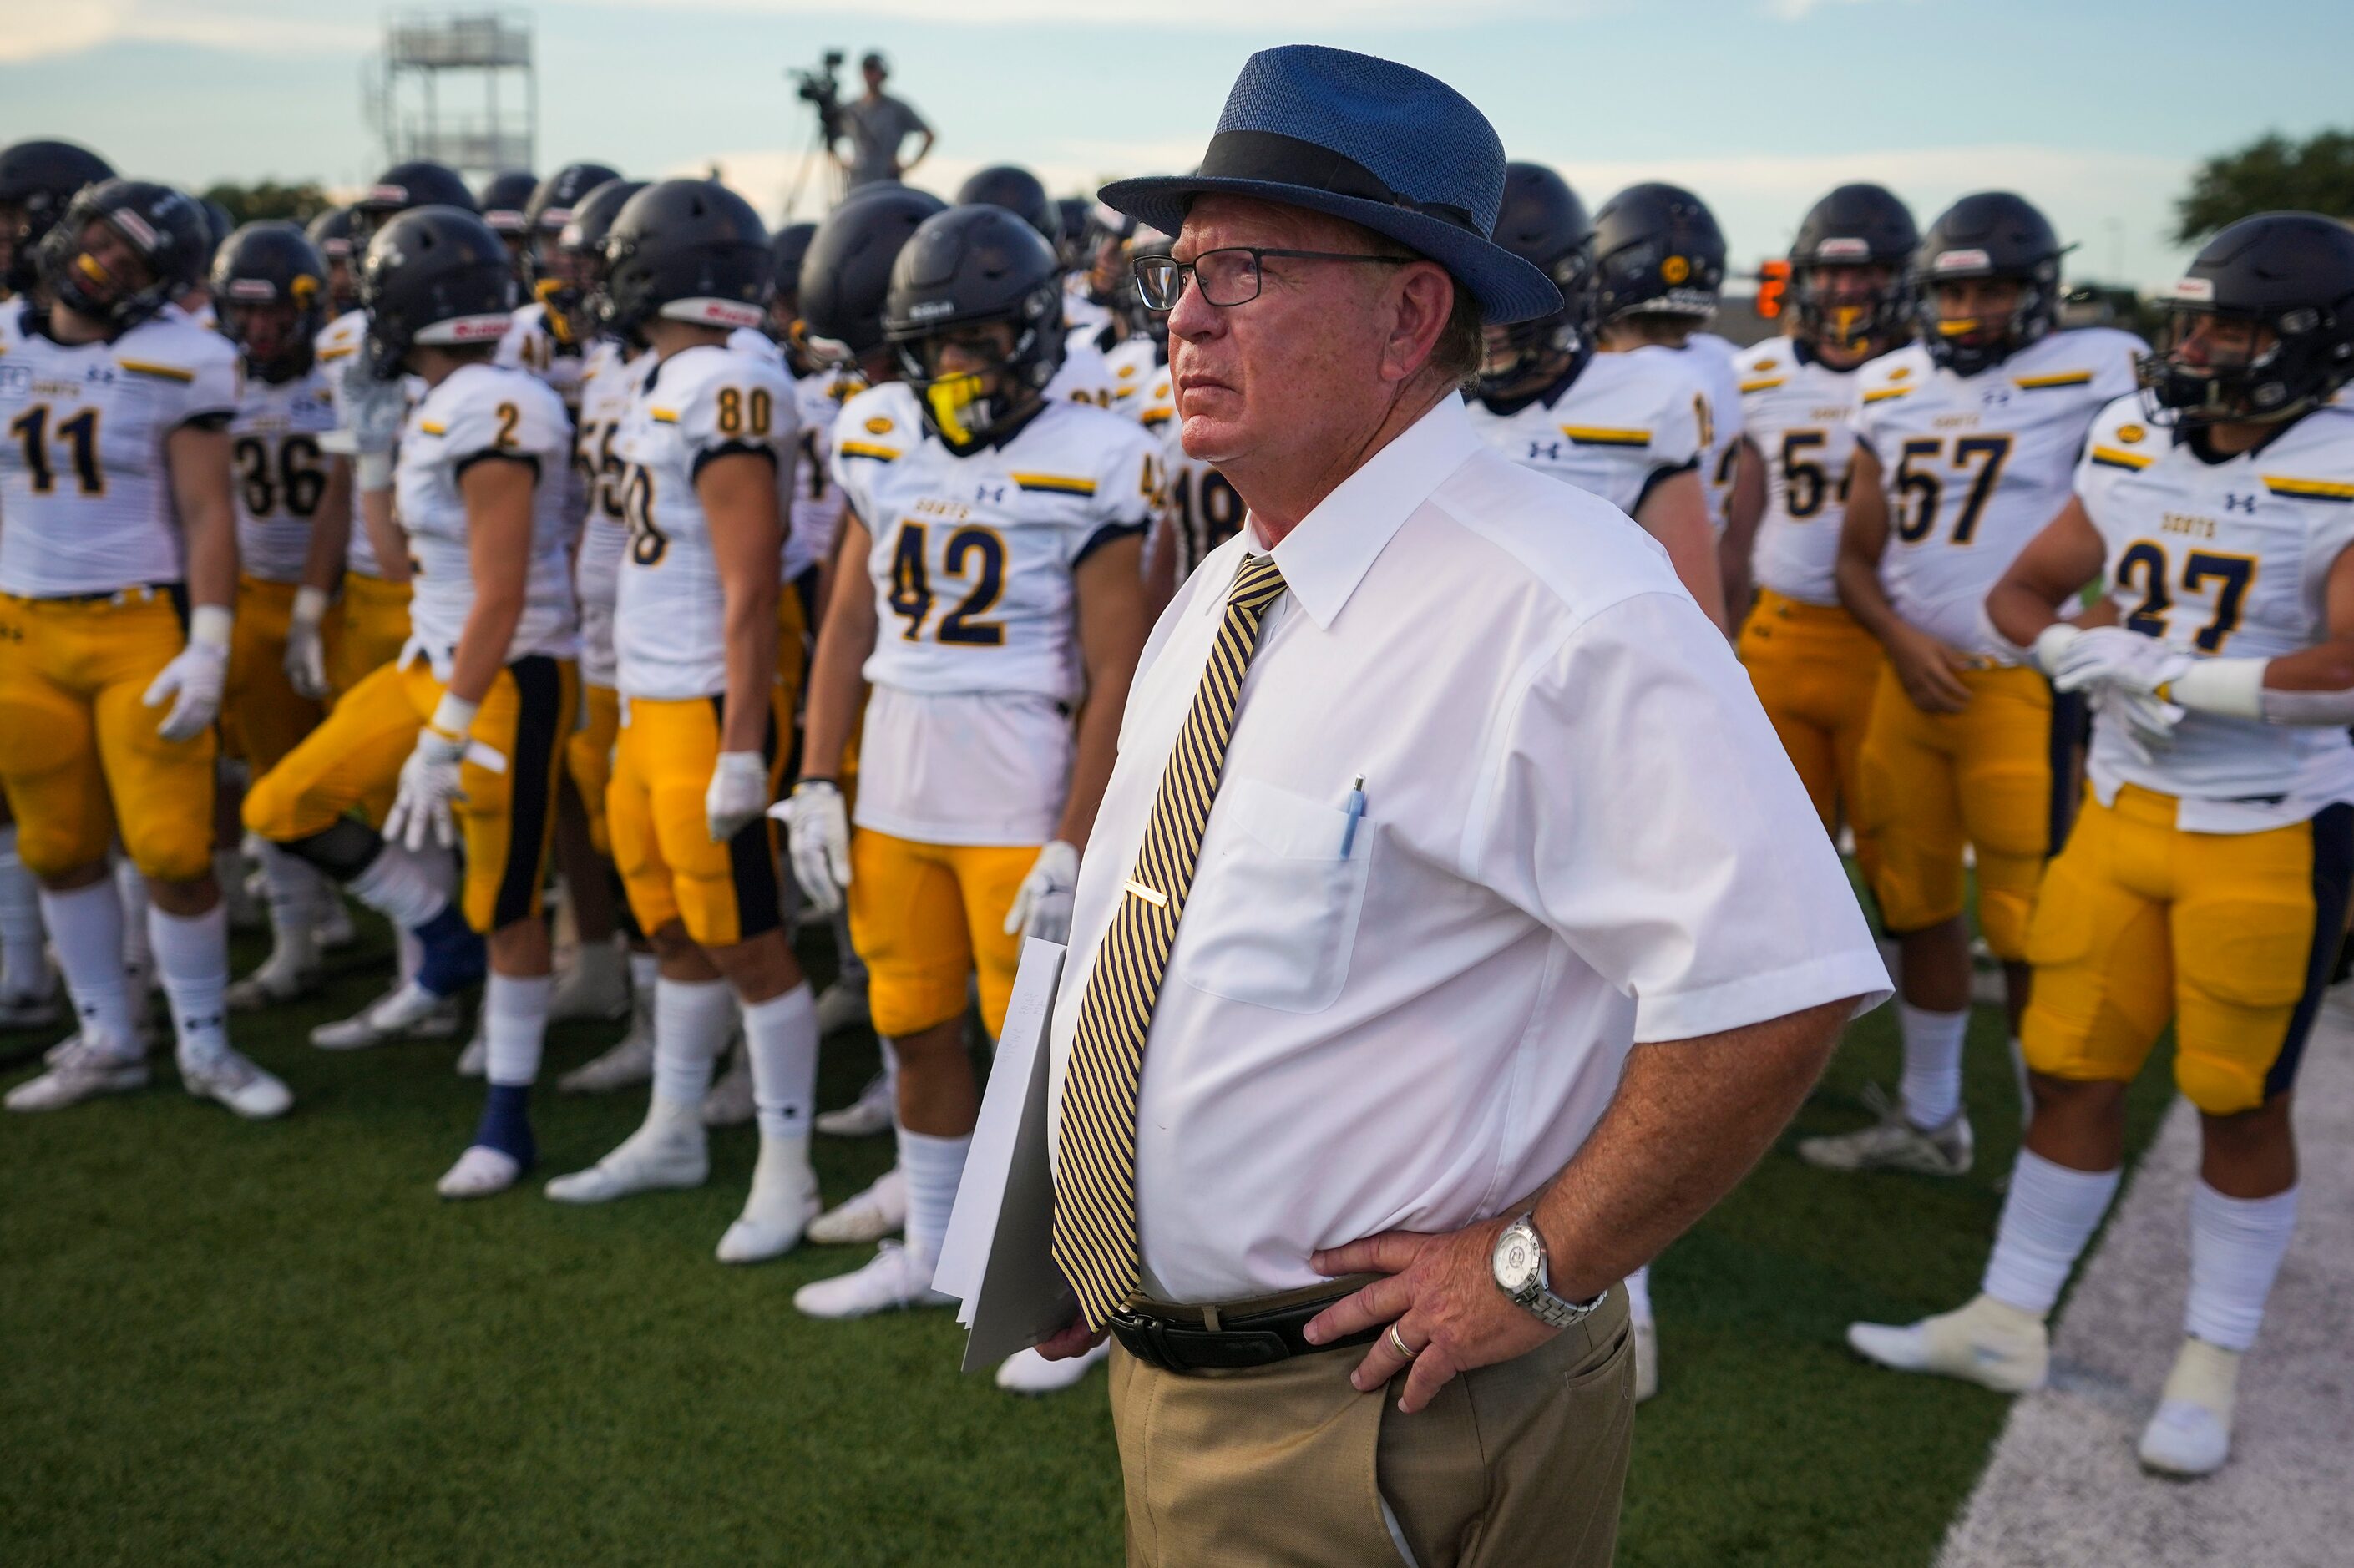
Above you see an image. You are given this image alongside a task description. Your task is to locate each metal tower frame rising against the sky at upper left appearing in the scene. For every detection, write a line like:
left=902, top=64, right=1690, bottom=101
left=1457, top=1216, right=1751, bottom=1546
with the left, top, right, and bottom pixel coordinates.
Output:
left=367, top=12, right=539, bottom=179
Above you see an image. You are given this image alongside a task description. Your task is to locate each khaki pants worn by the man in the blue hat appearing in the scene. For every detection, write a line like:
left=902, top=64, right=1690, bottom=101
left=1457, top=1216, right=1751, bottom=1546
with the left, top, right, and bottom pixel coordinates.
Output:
left=1111, top=1290, right=1633, bottom=1568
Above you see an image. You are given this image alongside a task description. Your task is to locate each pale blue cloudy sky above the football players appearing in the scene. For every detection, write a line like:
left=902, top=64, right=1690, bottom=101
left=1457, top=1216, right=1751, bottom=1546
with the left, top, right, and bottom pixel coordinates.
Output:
left=0, top=0, right=2354, bottom=285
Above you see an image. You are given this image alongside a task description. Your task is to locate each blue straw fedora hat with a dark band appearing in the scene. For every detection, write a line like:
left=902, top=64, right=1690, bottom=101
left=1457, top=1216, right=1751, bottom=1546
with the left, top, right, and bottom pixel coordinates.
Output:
left=1101, top=45, right=1561, bottom=325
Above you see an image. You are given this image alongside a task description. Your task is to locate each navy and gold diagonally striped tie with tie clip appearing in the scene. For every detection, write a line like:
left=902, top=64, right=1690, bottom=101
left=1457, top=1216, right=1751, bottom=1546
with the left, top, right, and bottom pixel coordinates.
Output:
left=1052, top=555, right=1283, bottom=1328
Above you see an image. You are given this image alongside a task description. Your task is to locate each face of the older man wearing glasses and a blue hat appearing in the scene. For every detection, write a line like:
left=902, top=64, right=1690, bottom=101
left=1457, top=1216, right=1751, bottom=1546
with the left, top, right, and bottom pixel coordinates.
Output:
left=1170, top=195, right=1396, bottom=462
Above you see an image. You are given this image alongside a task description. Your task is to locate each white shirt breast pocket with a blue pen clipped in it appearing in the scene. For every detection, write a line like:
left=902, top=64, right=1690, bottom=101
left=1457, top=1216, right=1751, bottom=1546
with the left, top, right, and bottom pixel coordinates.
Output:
left=1177, top=779, right=1374, bottom=1013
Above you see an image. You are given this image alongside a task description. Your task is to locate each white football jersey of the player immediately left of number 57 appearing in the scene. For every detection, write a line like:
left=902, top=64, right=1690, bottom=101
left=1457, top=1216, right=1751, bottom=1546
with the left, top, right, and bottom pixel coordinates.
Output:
left=1737, top=336, right=1862, bottom=605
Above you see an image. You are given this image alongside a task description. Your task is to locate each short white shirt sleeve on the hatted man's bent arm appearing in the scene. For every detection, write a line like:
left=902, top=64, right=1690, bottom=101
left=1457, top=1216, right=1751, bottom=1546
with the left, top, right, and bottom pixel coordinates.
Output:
left=1464, top=591, right=1891, bottom=1040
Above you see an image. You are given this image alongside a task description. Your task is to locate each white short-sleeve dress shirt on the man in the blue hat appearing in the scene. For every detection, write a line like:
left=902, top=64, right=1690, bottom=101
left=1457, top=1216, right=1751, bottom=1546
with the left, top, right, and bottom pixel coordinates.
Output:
left=1052, top=398, right=1888, bottom=1302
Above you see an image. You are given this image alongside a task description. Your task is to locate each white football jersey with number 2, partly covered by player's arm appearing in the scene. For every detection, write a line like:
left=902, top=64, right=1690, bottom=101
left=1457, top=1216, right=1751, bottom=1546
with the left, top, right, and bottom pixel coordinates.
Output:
left=393, top=365, right=579, bottom=680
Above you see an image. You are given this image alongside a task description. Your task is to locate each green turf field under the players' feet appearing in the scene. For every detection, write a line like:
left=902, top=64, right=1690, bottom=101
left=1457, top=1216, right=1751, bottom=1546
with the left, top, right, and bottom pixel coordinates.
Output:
left=0, top=908, right=2168, bottom=1568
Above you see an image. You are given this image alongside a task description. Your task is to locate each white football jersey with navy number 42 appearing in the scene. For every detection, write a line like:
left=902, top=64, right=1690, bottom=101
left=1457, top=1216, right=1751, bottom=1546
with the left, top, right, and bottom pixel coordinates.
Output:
left=833, top=384, right=1161, bottom=845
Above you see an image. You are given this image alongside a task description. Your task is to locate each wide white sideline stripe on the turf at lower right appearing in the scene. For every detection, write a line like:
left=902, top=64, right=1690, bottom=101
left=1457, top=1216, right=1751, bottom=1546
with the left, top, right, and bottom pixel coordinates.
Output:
left=1937, top=1005, right=2354, bottom=1568
